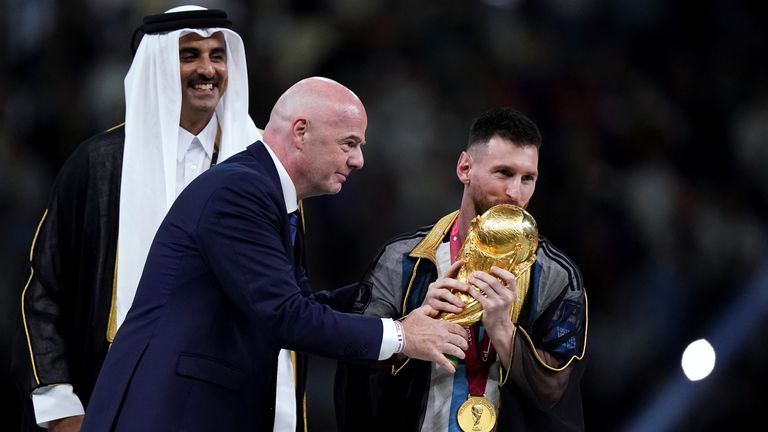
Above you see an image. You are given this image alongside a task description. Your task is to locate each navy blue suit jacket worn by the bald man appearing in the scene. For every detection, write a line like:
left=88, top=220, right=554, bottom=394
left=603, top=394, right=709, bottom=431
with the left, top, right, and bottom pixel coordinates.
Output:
left=83, top=142, right=382, bottom=432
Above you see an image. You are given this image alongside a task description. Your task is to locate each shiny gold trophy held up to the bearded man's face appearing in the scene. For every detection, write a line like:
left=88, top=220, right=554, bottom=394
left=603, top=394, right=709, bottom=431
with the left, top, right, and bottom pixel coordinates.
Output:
left=438, top=204, right=539, bottom=327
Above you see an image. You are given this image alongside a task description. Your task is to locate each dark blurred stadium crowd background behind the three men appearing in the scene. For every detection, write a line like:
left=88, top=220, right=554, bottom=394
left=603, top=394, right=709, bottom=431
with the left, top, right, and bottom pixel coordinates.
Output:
left=0, top=0, right=768, bottom=431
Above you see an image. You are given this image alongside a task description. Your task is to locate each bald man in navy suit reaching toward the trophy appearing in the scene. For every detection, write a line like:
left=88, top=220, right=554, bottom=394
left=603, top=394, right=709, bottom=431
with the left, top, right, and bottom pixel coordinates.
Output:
left=83, top=77, right=467, bottom=431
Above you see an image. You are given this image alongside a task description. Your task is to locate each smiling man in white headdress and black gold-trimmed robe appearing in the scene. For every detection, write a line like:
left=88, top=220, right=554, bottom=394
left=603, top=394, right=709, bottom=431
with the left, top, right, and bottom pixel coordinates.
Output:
left=12, top=6, right=261, bottom=431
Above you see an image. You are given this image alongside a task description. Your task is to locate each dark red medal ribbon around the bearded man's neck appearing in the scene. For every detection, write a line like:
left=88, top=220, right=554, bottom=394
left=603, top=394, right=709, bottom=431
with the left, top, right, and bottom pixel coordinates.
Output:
left=450, top=217, right=496, bottom=397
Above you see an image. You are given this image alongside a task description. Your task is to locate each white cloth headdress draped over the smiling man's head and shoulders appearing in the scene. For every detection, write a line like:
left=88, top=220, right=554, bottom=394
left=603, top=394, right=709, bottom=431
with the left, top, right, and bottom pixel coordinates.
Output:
left=115, top=8, right=261, bottom=327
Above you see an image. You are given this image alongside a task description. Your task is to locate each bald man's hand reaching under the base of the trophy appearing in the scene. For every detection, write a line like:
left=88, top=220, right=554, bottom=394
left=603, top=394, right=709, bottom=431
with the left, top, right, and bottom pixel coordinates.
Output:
left=400, top=305, right=468, bottom=373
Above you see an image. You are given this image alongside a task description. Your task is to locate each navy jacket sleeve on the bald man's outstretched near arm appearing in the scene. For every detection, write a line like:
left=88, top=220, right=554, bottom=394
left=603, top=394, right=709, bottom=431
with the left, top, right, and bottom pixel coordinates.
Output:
left=197, top=175, right=382, bottom=360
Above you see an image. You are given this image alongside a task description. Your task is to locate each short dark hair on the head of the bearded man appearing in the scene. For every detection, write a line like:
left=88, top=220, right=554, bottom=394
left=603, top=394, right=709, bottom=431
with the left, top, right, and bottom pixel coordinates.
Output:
left=467, top=107, right=541, bottom=149
